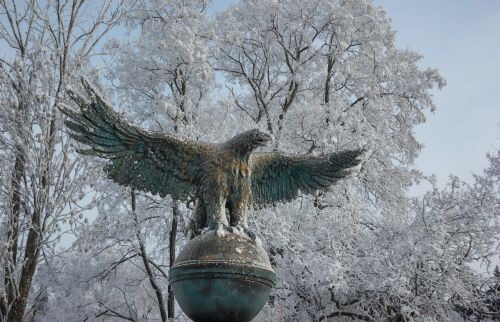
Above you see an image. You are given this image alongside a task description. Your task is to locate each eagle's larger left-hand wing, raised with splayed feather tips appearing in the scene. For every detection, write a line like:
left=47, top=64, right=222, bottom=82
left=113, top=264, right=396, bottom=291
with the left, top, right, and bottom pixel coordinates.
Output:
left=62, top=78, right=211, bottom=199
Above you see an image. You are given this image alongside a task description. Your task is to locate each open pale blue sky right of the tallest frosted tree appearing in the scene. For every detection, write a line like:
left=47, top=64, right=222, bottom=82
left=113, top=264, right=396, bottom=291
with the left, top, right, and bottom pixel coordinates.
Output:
left=212, top=0, right=500, bottom=189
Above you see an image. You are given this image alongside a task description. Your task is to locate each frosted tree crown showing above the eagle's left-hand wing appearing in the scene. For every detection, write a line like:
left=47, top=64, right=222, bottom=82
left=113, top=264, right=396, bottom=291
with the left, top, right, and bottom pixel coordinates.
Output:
left=107, top=0, right=213, bottom=135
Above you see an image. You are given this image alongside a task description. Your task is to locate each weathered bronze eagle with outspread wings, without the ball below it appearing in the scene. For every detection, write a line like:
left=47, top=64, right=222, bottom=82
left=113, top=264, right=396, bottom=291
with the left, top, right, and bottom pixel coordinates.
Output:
left=62, top=78, right=369, bottom=238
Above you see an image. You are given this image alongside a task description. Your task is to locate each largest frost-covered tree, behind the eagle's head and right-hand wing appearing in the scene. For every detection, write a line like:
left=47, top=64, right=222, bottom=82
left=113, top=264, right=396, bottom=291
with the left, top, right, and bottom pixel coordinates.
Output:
left=214, top=0, right=450, bottom=320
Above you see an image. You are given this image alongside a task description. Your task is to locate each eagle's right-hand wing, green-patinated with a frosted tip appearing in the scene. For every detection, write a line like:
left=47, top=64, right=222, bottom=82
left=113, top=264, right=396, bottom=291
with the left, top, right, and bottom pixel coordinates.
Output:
left=250, top=149, right=370, bottom=207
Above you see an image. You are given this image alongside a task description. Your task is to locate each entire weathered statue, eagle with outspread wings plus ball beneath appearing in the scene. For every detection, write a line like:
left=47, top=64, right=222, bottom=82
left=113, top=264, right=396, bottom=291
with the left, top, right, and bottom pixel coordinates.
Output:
left=62, top=78, right=370, bottom=322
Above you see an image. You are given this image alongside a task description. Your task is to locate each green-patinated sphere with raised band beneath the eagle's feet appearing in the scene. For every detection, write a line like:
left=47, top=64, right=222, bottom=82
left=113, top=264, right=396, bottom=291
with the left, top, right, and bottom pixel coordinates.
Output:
left=169, top=231, right=276, bottom=322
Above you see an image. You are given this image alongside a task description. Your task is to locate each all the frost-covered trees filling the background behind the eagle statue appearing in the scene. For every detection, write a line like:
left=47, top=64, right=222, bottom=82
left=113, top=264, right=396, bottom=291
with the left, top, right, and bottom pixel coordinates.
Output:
left=0, top=0, right=500, bottom=322
